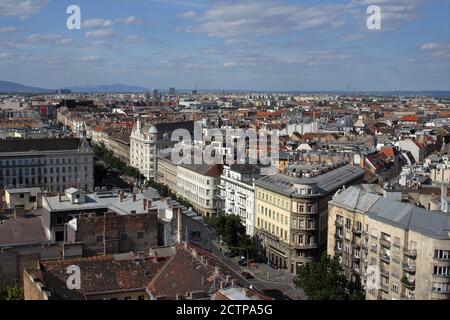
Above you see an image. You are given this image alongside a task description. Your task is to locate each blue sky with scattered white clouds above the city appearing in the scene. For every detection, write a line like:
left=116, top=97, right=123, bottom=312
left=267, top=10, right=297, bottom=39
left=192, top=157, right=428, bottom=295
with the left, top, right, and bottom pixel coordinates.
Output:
left=0, top=0, right=450, bottom=91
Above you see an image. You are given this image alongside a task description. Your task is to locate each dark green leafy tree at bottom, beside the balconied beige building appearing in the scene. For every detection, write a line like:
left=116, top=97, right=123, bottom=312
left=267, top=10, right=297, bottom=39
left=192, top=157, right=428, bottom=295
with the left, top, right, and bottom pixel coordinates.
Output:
left=294, top=253, right=349, bottom=300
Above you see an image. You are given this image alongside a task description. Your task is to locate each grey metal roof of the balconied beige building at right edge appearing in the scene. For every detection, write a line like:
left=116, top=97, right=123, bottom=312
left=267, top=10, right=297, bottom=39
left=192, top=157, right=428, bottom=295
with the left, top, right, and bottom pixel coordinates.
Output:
left=330, top=187, right=450, bottom=240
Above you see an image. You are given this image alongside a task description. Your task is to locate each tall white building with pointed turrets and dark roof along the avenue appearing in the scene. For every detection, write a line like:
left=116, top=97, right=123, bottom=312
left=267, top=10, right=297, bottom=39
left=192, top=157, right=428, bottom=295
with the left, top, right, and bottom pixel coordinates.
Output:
left=130, top=119, right=194, bottom=179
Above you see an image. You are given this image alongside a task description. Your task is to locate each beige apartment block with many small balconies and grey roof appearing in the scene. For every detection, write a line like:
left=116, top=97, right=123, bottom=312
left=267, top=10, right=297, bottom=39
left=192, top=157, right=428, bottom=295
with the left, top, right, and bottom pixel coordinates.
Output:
left=327, top=187, right=450, bottom=300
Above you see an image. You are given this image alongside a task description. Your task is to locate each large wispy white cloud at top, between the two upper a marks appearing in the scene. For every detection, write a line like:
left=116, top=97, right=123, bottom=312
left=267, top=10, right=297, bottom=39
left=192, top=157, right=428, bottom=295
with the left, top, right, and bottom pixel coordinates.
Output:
left=186, top=0, right=348, bottom=39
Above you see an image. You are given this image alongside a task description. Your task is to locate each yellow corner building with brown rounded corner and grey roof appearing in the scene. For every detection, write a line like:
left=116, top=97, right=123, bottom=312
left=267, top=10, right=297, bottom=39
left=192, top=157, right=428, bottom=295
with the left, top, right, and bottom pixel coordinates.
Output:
left=255, top=165, right=364, bottom=273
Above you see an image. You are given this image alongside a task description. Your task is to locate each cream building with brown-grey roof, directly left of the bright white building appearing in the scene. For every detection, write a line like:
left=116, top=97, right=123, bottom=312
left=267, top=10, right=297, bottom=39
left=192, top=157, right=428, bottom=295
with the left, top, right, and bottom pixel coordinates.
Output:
left=177, top=164, right=223, bottom=217
